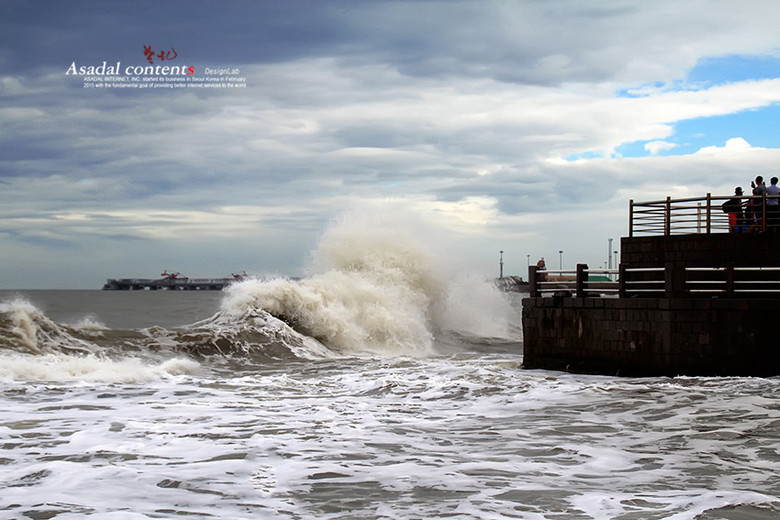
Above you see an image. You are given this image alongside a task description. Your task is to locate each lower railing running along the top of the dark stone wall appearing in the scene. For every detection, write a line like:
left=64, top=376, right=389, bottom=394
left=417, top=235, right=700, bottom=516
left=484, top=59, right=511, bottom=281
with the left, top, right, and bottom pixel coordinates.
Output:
left=528, top=262, right=780, bottom=298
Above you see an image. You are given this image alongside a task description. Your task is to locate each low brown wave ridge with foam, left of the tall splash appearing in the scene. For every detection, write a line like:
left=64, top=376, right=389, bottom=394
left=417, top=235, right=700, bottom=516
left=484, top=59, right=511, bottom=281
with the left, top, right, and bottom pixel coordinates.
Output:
left=0, top=299, right=333, bottom=383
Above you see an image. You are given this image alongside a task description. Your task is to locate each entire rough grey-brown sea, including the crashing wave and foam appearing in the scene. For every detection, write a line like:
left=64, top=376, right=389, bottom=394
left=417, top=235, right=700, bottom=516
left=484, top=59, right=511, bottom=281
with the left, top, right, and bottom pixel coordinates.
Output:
left=0, top=212, right=780, bottom=520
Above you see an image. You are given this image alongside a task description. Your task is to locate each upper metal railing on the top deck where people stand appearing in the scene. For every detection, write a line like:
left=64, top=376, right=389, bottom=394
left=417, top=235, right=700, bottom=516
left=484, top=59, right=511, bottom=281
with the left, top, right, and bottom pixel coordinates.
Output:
left=628, top=193, right=780, bottom=237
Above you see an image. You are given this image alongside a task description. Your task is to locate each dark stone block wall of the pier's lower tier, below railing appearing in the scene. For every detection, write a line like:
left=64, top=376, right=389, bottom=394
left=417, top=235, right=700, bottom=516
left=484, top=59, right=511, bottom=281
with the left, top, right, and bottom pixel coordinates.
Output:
left=523, top=297, right=780, bottom=376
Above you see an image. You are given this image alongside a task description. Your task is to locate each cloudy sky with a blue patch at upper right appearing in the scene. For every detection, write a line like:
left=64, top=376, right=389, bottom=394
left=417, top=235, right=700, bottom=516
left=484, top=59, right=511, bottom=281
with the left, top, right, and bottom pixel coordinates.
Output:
left=0, top=0, right=780, bottom=289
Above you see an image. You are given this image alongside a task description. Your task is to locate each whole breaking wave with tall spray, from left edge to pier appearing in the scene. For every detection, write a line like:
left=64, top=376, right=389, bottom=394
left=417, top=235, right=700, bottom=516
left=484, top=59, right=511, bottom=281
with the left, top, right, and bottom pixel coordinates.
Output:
left=0, top=206, right=517, bottom=381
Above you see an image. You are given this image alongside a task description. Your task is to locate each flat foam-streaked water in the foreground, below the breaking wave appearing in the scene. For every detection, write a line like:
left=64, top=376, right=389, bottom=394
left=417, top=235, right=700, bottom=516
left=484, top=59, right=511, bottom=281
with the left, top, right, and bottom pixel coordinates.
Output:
left=0, top=354, right=780, bottom=520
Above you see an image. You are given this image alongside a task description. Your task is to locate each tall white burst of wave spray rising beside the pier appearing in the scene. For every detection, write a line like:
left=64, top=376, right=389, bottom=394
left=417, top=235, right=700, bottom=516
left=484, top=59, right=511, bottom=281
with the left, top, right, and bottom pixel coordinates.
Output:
left=223, top=203, right=510, bottom=356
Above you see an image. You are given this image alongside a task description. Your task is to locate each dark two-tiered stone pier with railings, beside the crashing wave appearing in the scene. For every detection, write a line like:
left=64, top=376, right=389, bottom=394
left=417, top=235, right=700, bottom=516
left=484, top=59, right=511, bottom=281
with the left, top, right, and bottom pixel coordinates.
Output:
left=523, top=196, right=780, bottom=376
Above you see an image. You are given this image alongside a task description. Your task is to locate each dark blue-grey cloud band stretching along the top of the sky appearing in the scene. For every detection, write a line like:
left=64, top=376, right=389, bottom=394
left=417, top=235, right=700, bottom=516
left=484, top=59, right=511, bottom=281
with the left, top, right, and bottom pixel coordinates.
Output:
left=0, top=0, right=673, bottom=84
